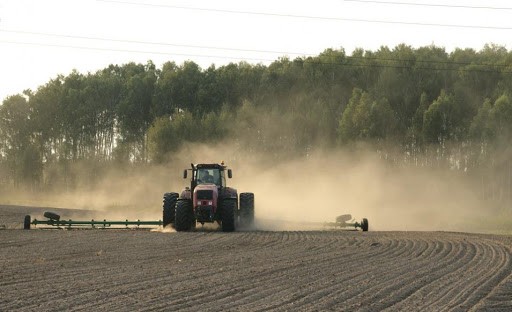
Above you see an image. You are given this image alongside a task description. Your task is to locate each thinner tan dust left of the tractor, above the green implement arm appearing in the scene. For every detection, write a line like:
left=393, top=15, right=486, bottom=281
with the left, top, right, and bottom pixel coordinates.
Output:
left=0, top=165, right=183, bottom=220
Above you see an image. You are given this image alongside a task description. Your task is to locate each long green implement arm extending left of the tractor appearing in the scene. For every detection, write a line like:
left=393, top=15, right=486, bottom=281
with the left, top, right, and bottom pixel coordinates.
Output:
left=23, top=211, right=163, bottom=230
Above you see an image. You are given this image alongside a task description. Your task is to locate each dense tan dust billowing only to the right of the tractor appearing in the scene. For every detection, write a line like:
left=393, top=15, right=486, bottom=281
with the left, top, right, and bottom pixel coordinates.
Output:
left=234, top=147, right=492, bottom=231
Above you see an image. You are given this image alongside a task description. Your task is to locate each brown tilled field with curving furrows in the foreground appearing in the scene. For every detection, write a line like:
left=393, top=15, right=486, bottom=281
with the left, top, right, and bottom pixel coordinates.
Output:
left=0, top=206, right=512, bottom=311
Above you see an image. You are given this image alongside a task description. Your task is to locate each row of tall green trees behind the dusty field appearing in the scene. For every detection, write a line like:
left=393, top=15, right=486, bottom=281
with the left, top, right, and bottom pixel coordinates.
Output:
left=0, top=44, right=512, bottom=197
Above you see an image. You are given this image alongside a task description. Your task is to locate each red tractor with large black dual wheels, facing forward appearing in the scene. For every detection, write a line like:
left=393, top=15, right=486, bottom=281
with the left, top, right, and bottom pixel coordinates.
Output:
left=163, top=163, right=254, bottom=232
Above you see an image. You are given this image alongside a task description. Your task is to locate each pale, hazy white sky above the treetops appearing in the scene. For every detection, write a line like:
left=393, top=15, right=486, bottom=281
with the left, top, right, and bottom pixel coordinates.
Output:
left=0, top=0, right=512, bottom=101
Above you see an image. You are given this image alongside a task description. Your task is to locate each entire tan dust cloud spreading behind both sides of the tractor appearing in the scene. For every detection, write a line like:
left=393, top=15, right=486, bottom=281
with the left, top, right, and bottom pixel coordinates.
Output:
left=3, top=144, right=508, bottom=232
